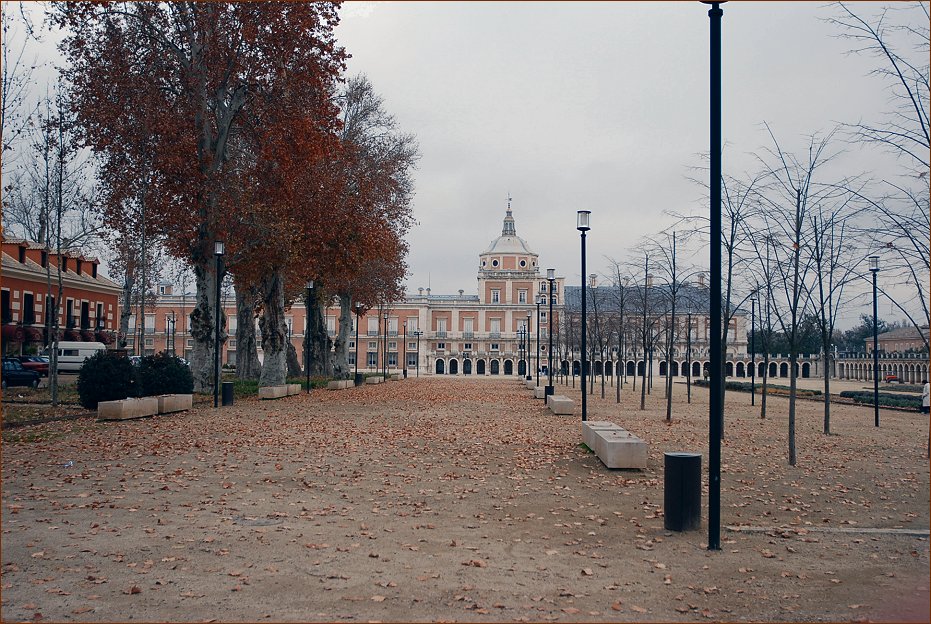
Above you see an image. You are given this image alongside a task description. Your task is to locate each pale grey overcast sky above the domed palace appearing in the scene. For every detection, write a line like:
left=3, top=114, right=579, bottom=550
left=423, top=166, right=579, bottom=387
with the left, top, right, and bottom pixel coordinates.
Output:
left=5, top=2, right=924, bottom=326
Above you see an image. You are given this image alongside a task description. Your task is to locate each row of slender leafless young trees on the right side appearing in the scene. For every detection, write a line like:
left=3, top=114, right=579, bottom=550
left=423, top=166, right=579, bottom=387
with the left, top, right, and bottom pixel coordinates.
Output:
left=559, top=3, right=931, bottom=465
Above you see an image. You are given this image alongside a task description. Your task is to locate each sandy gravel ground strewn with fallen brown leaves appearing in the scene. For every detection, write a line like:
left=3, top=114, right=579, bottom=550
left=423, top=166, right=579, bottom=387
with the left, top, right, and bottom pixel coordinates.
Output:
left=0, top=377, right=929, bottom=622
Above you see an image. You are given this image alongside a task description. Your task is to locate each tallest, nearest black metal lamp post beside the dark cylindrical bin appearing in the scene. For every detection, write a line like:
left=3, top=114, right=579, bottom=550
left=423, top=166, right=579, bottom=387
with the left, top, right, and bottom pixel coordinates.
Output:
left=708, top=2, right=724, bottom=550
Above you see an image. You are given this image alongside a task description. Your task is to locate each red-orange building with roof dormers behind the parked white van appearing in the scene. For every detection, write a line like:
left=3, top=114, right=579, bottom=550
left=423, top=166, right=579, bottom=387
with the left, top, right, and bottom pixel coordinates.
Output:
left=0, top=237, right=120, bottom=355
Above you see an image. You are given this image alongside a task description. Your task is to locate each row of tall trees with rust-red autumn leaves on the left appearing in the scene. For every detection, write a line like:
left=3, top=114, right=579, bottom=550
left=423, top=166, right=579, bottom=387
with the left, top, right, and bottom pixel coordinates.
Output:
left=4, top=2, right=419, bottom=390
